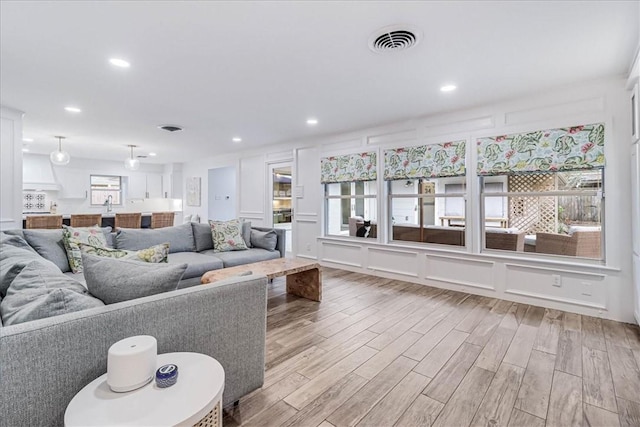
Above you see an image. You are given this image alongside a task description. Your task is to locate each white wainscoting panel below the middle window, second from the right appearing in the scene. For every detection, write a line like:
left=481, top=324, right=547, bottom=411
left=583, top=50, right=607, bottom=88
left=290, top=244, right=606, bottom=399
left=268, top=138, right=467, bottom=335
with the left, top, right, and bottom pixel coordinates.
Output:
left=425, top=254, right=496, bottom=290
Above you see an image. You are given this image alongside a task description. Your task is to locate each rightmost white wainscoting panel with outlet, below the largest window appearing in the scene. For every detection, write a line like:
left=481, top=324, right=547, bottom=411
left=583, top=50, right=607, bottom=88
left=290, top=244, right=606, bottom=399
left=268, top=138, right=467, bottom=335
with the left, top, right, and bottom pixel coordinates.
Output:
left=505, top=264, right=607, bottom=310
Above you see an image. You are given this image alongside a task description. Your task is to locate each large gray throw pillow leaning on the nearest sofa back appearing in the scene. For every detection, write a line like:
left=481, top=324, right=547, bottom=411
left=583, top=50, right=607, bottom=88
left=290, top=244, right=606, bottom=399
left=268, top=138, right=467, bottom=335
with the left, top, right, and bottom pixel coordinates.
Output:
left=82, top=254, right=189, bottom=304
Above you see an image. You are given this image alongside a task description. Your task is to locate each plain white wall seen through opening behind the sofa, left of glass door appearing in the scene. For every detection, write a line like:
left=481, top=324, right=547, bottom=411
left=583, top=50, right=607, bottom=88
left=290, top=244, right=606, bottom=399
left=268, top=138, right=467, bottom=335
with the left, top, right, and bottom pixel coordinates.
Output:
left=208, top=167, right=237, bottom=221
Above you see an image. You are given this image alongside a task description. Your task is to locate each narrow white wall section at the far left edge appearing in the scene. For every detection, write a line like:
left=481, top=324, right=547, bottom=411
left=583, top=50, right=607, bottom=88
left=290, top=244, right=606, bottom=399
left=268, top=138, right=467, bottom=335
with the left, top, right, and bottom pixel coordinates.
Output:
left=0, top=106, right=23, bottom=230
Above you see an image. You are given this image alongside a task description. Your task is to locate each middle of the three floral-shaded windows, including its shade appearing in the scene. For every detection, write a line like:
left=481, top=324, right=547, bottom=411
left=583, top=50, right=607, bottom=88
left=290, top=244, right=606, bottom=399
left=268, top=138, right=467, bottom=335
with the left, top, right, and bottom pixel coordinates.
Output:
left=384, top=141, right=466, bottom=246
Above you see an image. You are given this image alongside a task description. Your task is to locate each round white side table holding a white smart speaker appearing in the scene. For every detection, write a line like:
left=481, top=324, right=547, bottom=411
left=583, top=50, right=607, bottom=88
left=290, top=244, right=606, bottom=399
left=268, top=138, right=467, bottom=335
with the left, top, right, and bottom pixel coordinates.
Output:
left=64, top=353, right=224, bottom=427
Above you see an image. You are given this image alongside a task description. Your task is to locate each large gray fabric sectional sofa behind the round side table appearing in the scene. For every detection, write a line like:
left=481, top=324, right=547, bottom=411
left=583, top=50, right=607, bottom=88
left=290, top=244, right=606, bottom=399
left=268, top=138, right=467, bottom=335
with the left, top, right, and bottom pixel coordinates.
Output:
left=0, top=224, right=285, bottom=427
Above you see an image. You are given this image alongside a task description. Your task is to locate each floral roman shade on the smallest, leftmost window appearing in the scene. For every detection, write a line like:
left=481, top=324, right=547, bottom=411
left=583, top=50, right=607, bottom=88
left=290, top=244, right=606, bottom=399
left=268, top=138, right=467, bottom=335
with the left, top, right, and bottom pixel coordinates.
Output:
left=320, top=151, right=378, bottom=184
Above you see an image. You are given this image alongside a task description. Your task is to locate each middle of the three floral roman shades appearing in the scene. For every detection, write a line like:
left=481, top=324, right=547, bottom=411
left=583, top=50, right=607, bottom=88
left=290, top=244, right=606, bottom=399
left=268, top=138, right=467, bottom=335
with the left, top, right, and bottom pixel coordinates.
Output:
left=384, top=141, right=466, bottom=180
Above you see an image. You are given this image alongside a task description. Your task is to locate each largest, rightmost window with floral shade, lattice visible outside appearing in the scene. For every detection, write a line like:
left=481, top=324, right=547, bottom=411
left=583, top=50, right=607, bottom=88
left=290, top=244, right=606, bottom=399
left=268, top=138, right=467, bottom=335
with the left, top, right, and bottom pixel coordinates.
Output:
left=478, top=124, right=604, bottom=260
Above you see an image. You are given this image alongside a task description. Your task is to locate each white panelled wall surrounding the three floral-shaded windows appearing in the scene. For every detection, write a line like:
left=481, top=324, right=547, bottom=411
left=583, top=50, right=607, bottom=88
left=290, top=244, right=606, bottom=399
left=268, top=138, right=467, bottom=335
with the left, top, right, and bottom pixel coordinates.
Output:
left=184, top=79, right=634, bottom=322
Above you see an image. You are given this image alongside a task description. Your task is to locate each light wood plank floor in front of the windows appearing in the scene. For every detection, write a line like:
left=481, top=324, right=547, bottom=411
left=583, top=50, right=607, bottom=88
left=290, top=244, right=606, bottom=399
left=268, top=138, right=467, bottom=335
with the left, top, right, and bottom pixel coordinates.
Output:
left=224, top=268, right=640, bottom=427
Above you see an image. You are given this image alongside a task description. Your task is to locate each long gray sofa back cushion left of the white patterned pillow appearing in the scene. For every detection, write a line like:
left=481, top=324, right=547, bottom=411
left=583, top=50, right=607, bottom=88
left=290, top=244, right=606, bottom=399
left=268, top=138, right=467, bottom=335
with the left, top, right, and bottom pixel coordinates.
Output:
left=116, top=224, right=196, bottom=253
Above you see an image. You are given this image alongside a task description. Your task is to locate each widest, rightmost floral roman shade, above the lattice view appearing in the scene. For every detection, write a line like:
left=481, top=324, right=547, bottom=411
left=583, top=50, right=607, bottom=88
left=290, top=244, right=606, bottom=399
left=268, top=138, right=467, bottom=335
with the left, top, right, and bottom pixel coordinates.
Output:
left=478, top=123, right=604, bottom=175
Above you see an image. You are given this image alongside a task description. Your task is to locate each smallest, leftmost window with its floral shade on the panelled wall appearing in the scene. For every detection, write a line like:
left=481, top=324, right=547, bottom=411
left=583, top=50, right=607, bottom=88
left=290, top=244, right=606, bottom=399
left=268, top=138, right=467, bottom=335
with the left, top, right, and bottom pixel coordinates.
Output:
left=321, top=151, right=378, bottom=238
